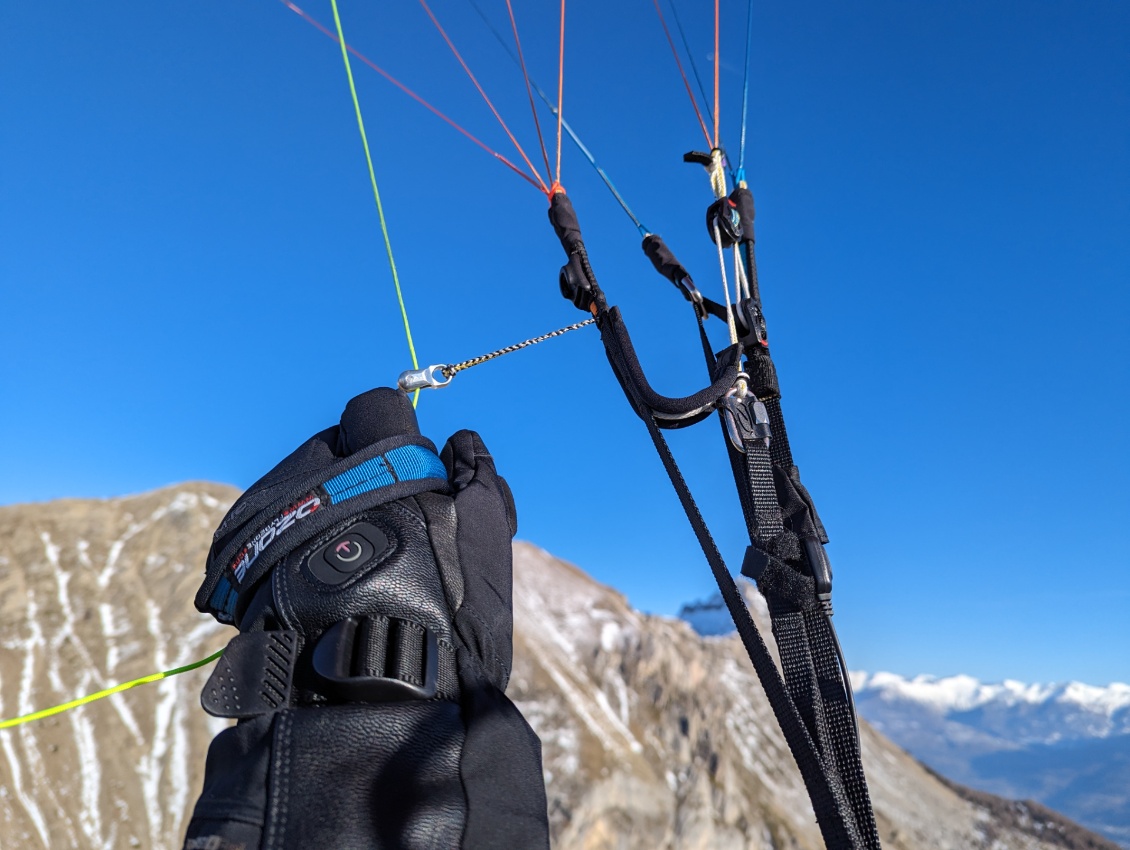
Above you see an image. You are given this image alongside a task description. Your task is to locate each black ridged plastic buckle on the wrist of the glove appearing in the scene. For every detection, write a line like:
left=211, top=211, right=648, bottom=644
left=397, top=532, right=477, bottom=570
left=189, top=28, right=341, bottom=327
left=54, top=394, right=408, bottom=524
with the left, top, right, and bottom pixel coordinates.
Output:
left=312, top=615, right=440, bottom=702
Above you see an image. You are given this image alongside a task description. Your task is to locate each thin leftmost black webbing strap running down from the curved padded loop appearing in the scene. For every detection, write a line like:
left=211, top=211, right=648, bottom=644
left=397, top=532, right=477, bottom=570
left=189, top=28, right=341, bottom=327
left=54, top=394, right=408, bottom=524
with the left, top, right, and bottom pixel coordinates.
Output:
left=644, top=416, right=869, bottom=850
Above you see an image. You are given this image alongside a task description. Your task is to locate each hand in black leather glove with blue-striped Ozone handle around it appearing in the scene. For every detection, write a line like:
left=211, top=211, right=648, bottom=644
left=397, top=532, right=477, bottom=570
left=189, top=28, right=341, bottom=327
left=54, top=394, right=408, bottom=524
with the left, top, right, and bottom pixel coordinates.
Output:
left=184, top=389, right=549, bottom=850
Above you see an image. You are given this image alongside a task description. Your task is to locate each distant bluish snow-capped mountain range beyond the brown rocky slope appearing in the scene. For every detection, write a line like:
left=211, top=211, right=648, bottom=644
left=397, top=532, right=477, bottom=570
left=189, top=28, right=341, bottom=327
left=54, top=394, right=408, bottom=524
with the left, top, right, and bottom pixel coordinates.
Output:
left=679, top=586, right=1130, bottom=848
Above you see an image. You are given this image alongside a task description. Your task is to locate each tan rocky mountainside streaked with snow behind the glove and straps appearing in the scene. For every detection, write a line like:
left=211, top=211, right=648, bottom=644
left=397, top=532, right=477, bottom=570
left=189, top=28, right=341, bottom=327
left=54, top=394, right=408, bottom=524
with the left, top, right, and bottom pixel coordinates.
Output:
left=0, top=484, right=1114, bottom=850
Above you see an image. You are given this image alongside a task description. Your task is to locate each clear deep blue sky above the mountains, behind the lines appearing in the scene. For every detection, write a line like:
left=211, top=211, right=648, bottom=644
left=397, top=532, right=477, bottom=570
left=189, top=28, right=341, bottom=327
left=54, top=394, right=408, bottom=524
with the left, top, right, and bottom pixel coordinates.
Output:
left=0, top=0, right=1130, bottom=684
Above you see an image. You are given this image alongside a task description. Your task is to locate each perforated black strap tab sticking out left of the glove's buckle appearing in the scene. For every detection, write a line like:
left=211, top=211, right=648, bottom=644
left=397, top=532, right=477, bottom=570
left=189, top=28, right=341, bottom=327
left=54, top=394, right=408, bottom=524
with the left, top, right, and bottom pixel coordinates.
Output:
left=200, top=631, right=298, bottom=719
